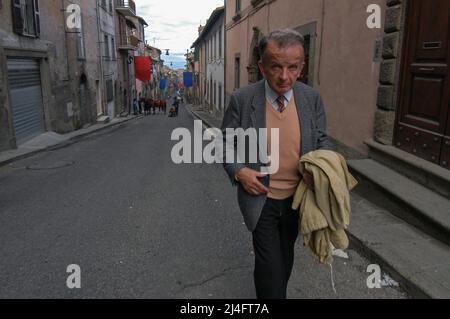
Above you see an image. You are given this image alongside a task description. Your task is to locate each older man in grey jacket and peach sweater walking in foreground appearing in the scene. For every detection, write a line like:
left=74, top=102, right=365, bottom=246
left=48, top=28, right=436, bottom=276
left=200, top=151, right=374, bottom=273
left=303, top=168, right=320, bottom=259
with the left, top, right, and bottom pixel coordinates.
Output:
left=222, top=29, right=333, bottom=299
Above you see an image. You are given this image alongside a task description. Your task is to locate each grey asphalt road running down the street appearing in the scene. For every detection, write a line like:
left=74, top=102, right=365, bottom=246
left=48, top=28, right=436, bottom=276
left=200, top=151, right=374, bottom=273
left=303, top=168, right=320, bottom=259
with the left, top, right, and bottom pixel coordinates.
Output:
left=0, top=102, right=406, bottom=299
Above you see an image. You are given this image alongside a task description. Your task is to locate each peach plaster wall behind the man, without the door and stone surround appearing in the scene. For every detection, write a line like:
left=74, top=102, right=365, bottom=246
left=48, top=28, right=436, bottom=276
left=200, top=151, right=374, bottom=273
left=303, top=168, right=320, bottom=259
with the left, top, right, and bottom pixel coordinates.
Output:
left=225, top=0, right=385, bottom=158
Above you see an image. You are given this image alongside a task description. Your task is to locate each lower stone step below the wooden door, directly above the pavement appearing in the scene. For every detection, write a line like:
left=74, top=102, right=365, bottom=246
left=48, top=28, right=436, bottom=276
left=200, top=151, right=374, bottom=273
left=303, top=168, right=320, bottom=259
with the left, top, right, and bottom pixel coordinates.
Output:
left=348, top=159, right=450, bottom=245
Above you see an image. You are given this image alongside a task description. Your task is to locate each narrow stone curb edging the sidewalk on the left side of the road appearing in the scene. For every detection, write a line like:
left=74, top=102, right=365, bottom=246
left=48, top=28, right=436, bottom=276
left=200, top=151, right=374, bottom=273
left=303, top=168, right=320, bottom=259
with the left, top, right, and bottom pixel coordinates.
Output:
left=0, top=116, right=143, bottom=167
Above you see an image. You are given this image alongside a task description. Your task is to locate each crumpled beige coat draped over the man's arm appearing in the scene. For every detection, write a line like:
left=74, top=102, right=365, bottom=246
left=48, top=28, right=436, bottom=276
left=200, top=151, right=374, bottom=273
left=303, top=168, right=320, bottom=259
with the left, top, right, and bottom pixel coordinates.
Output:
left=292, top=150, right=358, bottom=264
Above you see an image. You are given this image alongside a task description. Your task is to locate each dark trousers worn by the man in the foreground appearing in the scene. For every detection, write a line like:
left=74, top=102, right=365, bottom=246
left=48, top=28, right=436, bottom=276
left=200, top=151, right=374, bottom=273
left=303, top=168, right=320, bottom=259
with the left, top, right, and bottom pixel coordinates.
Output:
left=253, top=198, right=299, bottom=299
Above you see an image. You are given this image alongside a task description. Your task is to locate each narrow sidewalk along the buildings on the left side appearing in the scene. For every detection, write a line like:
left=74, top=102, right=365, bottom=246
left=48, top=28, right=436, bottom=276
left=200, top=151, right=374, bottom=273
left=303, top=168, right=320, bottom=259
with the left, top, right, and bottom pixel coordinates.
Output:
left=0, top=115, right=142, bottom=167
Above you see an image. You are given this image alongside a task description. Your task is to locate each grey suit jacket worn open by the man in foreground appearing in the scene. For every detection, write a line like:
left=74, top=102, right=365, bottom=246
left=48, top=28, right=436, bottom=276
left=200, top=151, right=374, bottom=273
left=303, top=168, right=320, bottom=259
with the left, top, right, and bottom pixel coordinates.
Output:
left=222, top=80, right=334, bottom=232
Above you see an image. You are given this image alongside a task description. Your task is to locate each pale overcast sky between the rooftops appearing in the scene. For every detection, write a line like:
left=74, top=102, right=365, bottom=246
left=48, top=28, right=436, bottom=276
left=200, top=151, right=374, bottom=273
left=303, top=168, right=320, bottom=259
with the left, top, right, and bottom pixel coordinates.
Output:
left=135, top=0, right=224, bottom=67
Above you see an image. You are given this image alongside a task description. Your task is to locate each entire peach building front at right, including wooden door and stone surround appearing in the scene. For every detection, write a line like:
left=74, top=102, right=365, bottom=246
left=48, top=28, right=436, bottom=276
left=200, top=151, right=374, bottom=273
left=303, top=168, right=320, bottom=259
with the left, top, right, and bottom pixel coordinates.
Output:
left=225, top=0, right=450, bottom=183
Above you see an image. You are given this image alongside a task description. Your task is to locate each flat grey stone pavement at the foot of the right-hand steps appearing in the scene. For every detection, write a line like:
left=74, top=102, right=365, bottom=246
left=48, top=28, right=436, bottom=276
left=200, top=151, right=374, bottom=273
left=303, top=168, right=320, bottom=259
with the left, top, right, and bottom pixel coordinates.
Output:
left=348, top=192, right=450, bottom=299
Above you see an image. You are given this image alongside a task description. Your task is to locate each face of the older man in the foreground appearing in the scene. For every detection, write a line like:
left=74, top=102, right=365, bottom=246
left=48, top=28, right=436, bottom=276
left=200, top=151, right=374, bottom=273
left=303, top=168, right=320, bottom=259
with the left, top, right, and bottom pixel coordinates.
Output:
left=258, top=41, right=305, bottom=95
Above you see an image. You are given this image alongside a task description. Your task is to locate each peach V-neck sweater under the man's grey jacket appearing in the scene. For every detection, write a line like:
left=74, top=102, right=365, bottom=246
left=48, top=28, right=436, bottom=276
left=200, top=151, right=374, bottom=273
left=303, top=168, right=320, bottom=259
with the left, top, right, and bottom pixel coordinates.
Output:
left=266, top=98, right=301, bottom=200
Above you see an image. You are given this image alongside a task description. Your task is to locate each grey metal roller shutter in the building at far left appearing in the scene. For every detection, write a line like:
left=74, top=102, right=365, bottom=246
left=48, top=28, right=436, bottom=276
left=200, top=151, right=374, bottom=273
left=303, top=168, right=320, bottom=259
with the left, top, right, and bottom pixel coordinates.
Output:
left=7, top=59, right=45, bottom=144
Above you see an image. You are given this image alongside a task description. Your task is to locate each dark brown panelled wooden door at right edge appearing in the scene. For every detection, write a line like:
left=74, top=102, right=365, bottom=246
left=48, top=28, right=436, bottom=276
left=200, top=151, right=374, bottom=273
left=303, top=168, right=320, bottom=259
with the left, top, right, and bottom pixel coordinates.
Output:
left=394, top=0, right=450, bottom=169
